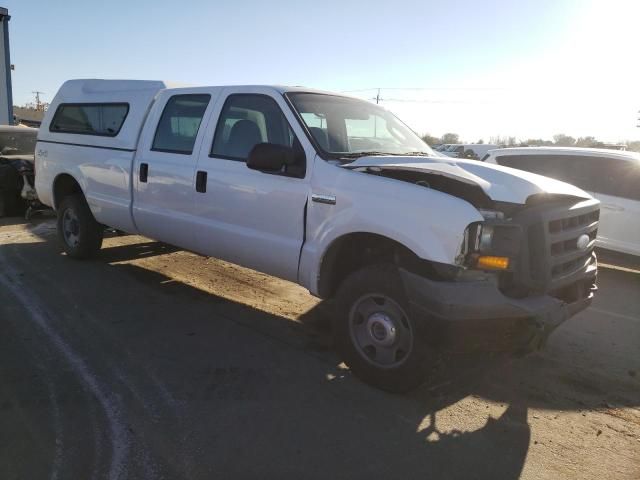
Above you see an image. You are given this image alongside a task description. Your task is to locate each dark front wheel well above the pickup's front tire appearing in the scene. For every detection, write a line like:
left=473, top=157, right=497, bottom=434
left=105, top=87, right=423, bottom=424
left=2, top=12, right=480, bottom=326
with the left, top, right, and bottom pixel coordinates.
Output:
left=318, top=233, right=433, bottom=298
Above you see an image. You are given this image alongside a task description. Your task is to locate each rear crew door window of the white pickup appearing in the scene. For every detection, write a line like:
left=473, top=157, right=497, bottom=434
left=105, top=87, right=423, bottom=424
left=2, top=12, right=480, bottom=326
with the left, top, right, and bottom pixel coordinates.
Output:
left=151, top=93, right=211, bottom=155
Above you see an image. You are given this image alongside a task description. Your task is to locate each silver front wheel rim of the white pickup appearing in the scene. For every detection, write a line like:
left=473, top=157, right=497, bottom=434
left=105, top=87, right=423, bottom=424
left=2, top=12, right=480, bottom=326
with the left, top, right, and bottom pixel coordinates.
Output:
left=349, top=294, right=413, bottom=368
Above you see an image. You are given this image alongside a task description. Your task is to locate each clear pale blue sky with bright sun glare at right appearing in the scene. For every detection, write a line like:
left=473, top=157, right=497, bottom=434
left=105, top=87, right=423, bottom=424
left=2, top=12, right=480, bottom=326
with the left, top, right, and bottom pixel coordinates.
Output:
left=5, top=0, right=640, bottom=142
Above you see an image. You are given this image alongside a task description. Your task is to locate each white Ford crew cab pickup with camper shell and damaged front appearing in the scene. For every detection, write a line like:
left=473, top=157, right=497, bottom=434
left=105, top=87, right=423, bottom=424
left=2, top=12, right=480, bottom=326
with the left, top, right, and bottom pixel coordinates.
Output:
left=36, top=80, right=599, bottom=391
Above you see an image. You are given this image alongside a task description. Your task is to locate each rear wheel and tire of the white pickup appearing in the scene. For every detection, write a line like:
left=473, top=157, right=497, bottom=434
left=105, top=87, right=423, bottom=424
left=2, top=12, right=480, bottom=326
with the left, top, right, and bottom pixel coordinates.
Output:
left=57, top=194, right=104, bottom=259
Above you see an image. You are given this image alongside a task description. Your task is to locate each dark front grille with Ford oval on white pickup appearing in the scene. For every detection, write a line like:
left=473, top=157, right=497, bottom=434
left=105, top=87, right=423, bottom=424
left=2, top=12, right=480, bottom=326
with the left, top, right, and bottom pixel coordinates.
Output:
left=518, top=199, right=600, bottom=292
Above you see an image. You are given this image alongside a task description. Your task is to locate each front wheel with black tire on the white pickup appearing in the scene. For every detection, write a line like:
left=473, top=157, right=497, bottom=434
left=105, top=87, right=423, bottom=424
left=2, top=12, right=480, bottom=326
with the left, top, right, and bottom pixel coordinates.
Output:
left=333, top=264, right=434, bottom=393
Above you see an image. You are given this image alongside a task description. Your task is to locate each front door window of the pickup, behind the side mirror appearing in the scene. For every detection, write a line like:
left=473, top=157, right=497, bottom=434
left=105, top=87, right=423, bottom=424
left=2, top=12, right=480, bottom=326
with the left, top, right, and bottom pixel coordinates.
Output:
left=210, top=94, right=297, bottom=161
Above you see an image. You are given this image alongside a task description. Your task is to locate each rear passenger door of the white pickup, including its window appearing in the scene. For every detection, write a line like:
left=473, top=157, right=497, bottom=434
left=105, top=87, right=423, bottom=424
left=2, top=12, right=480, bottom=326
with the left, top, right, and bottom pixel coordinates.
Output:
left=133, top=89, right=216, bottom=249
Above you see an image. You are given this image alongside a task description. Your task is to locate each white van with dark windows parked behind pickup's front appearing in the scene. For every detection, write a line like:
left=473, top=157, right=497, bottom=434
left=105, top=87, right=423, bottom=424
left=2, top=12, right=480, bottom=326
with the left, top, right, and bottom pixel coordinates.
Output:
left=483, top=147, right=640, bottom=255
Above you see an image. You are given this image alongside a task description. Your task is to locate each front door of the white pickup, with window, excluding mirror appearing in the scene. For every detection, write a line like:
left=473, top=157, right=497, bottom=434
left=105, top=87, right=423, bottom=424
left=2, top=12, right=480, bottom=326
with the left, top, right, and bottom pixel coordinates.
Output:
left=195, top=87, right=314, bottom=281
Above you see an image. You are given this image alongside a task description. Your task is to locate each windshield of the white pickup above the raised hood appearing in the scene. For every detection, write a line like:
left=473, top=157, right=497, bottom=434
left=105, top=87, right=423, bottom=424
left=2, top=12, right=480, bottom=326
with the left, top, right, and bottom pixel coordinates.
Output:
left=287, top=93, right=434, bottom=159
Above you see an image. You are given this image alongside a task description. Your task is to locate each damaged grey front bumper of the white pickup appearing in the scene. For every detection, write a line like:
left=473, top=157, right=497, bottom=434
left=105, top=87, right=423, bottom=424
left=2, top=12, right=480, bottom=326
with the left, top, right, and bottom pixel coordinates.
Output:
left=400, top=266, right=597, bottom=354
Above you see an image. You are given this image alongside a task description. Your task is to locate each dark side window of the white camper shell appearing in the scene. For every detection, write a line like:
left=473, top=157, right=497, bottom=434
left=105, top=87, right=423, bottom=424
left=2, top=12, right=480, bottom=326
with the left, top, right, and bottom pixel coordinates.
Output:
left=49, top=103, right=129, bottom=137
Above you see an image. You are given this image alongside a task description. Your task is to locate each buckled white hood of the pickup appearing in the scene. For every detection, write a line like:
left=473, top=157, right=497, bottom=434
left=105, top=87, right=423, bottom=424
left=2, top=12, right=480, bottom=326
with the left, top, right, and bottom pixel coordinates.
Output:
left=343, top=155, right=591, bottom=204
